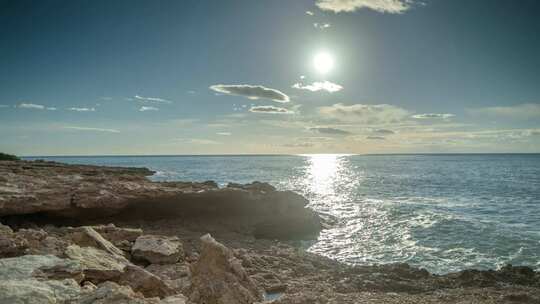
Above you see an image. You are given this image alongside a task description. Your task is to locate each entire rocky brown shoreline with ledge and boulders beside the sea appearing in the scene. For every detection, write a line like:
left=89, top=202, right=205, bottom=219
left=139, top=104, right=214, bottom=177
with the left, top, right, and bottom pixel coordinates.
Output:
left=0, top=161, right=540, bottom=304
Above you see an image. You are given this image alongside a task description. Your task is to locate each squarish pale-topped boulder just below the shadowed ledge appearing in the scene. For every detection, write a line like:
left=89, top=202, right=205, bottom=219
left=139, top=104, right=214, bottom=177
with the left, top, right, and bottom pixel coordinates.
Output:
left=131, top=235, right=184, bottom=264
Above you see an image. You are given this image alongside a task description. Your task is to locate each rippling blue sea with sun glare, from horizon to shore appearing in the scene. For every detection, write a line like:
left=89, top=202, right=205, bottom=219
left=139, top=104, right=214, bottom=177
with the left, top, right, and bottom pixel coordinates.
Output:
left=26, top=154, right=540, bottom=273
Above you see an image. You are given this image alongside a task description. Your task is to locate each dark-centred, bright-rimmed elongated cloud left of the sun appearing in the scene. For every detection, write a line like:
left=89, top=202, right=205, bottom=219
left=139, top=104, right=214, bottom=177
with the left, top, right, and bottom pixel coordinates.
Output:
left=210, top=84, right=290, bottom=102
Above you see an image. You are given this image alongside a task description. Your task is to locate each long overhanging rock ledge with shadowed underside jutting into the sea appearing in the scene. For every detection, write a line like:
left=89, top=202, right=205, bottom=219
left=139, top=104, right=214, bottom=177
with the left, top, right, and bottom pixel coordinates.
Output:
left=0, top=161, right=322, bottom=239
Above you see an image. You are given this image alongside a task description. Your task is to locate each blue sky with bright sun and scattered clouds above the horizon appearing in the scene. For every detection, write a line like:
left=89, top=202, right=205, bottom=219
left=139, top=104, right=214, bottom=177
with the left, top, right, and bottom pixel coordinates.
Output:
left=0, top=0, right=540, bottom=156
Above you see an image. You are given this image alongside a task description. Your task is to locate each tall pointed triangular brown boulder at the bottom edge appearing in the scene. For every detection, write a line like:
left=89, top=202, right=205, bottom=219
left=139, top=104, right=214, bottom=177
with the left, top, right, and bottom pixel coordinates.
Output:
left=189, top=234, right=262, bottom=304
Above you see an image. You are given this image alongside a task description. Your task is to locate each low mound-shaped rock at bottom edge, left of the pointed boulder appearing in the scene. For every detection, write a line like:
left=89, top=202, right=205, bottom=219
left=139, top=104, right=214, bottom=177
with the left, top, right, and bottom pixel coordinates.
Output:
left=77, top=282, right=160, bottom=304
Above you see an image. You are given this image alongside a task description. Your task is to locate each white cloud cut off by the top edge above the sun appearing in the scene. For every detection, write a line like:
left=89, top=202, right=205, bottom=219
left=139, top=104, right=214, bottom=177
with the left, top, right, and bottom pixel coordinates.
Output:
left=315, top=0, right=413, bottom=14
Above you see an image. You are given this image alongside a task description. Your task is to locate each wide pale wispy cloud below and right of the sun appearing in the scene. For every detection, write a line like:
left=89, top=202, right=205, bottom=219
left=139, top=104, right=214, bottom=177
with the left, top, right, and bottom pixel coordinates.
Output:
left=317, top=103, right=410, bottom=124
